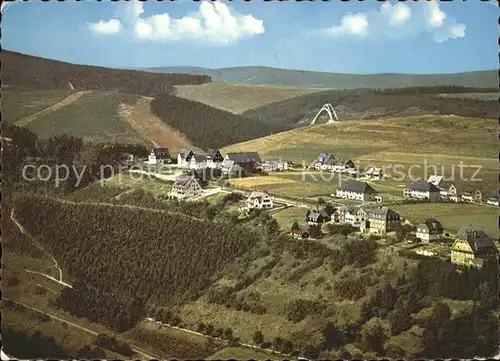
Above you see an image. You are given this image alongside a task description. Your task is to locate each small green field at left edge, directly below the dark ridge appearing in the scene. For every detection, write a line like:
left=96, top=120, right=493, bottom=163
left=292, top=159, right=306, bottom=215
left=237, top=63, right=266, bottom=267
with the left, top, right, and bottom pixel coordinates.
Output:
left=2, top=89, right=73, bottom=123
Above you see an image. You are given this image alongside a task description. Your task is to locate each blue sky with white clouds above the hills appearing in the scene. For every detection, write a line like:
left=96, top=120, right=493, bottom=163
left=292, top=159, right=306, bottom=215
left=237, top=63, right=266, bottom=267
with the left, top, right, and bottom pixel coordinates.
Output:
left=1, top=0, right=500, bottom=74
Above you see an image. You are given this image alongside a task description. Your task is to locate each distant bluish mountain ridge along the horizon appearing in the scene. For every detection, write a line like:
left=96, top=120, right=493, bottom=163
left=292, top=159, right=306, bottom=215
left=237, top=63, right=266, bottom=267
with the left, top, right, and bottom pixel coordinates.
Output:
left=143, top=66, right=498, bottom=89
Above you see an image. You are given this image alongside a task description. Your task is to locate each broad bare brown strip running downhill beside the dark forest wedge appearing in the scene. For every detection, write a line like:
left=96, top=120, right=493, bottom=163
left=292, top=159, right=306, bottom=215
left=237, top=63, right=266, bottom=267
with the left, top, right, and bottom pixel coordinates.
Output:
left=119, top=97, right=201, bottom=152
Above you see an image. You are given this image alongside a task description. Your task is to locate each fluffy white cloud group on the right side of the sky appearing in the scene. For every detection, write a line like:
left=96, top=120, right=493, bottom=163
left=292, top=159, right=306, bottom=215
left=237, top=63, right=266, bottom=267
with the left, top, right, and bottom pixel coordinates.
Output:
left=313, top=0, right=466, bottom=43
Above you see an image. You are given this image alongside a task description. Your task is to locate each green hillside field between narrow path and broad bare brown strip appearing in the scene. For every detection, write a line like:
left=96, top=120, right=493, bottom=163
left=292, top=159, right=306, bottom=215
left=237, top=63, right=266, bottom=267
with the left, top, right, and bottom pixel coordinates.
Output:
left=28, top=92, right=145, bottom=143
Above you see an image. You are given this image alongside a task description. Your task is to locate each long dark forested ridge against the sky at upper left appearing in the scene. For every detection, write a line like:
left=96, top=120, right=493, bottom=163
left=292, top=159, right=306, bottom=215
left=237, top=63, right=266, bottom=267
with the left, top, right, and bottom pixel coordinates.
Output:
left=1, top=50, right=210, bottom=95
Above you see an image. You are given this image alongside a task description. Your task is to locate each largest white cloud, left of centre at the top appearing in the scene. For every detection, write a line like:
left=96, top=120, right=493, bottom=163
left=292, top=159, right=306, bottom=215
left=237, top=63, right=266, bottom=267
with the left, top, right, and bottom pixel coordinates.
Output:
left=89, top=1, right=264, bottom=45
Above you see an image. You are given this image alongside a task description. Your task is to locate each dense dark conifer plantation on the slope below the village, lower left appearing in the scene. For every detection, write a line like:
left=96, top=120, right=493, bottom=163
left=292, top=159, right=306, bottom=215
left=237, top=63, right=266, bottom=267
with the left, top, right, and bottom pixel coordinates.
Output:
left=15, top=198, right=257, bottom=331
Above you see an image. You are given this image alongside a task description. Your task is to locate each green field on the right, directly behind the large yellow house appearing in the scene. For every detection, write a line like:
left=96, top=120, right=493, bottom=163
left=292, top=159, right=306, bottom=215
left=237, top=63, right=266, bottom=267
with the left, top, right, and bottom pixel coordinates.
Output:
left=391, top=203, right=499, bottom=239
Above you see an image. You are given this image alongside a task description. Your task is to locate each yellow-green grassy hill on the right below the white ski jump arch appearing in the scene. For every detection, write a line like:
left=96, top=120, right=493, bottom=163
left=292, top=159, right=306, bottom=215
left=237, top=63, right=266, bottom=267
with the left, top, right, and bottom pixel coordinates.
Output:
left=223, top=115, right=498, bottom=194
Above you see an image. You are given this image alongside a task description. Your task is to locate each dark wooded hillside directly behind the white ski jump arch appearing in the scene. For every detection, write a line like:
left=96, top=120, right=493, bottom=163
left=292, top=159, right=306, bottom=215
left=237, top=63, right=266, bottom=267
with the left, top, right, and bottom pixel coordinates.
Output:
left=242, top=86, right=498, bottom=128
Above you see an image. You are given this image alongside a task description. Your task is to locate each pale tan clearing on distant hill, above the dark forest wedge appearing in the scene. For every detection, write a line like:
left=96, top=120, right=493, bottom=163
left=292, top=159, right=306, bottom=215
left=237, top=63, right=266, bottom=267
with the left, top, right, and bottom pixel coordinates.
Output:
left=176, top=83, right=325, bottom=114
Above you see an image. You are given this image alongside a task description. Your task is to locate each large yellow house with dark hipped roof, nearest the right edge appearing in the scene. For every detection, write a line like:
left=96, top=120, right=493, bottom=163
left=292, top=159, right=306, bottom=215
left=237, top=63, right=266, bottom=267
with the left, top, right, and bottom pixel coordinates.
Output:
left=451, top=224, right=498, bottom=266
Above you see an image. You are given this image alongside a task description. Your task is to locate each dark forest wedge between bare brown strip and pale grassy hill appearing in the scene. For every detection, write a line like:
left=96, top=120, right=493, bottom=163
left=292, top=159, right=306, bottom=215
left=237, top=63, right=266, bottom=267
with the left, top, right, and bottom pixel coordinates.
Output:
left=151, top=94, right=273, bottom=149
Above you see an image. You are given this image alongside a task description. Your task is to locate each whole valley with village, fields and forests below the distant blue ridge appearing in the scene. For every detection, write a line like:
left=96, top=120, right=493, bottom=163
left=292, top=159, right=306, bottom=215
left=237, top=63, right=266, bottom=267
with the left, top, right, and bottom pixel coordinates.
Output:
left=2, top=48, right=499, bottom=360
